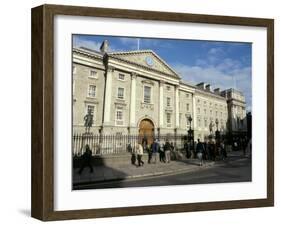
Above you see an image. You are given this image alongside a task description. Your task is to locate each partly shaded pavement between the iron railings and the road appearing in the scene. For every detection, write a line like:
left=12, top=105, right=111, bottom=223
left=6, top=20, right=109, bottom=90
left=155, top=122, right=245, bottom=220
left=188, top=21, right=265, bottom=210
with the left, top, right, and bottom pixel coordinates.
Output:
left=73, top=151, right=249, bottom=189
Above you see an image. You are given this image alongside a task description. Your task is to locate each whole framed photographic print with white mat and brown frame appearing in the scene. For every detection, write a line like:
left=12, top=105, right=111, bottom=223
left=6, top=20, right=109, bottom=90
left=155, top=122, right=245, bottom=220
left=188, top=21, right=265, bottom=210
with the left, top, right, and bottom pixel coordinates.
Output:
left=32, top=5, right=274, bottom=221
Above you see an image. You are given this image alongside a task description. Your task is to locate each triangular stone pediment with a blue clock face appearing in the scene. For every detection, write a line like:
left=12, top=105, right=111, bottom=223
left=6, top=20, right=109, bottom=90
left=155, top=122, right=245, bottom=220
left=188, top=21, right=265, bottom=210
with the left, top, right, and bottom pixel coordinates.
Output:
left=108, top=50, right=180, bottom=78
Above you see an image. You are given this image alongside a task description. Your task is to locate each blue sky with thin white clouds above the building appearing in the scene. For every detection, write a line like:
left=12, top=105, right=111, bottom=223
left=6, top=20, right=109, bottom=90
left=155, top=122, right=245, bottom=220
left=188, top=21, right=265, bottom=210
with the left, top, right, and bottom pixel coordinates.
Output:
left=73, top=35, right=252, bottom=111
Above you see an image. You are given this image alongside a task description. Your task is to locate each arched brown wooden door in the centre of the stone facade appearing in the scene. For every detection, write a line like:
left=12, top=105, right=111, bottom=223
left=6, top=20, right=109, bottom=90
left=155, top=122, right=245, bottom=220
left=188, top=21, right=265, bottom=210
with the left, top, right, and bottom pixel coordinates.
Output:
left=139, top=119, right=154, bottom=145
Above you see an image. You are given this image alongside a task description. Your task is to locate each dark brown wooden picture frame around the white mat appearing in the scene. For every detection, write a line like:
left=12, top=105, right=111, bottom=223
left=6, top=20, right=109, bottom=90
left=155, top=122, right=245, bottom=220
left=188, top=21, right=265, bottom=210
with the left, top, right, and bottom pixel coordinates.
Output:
left=31, top=5, right=274, bottom=221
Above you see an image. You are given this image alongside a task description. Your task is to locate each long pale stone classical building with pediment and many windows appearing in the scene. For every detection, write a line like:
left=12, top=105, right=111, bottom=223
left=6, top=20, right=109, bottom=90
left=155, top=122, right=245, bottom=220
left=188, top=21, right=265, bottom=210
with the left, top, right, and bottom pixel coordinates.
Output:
left=73, top=41, right=247, bottom=140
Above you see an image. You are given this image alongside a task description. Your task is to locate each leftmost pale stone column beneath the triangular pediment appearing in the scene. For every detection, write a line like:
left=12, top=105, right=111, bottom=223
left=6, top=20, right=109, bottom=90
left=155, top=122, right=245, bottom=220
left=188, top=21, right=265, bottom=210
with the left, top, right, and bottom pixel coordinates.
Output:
left=103, top=67, right=114, bottom=125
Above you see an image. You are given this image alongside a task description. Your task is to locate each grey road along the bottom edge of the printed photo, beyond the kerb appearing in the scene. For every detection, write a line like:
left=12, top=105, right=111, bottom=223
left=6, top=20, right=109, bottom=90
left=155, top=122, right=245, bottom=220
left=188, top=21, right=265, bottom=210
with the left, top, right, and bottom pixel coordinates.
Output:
left=75, top=151, right=251, bottom=189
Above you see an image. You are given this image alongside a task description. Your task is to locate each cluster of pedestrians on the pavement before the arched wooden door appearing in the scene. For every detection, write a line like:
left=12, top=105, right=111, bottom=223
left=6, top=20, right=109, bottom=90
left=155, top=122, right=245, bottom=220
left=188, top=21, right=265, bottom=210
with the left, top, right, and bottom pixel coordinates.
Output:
left=128, top=139, right=174, bottom=167
